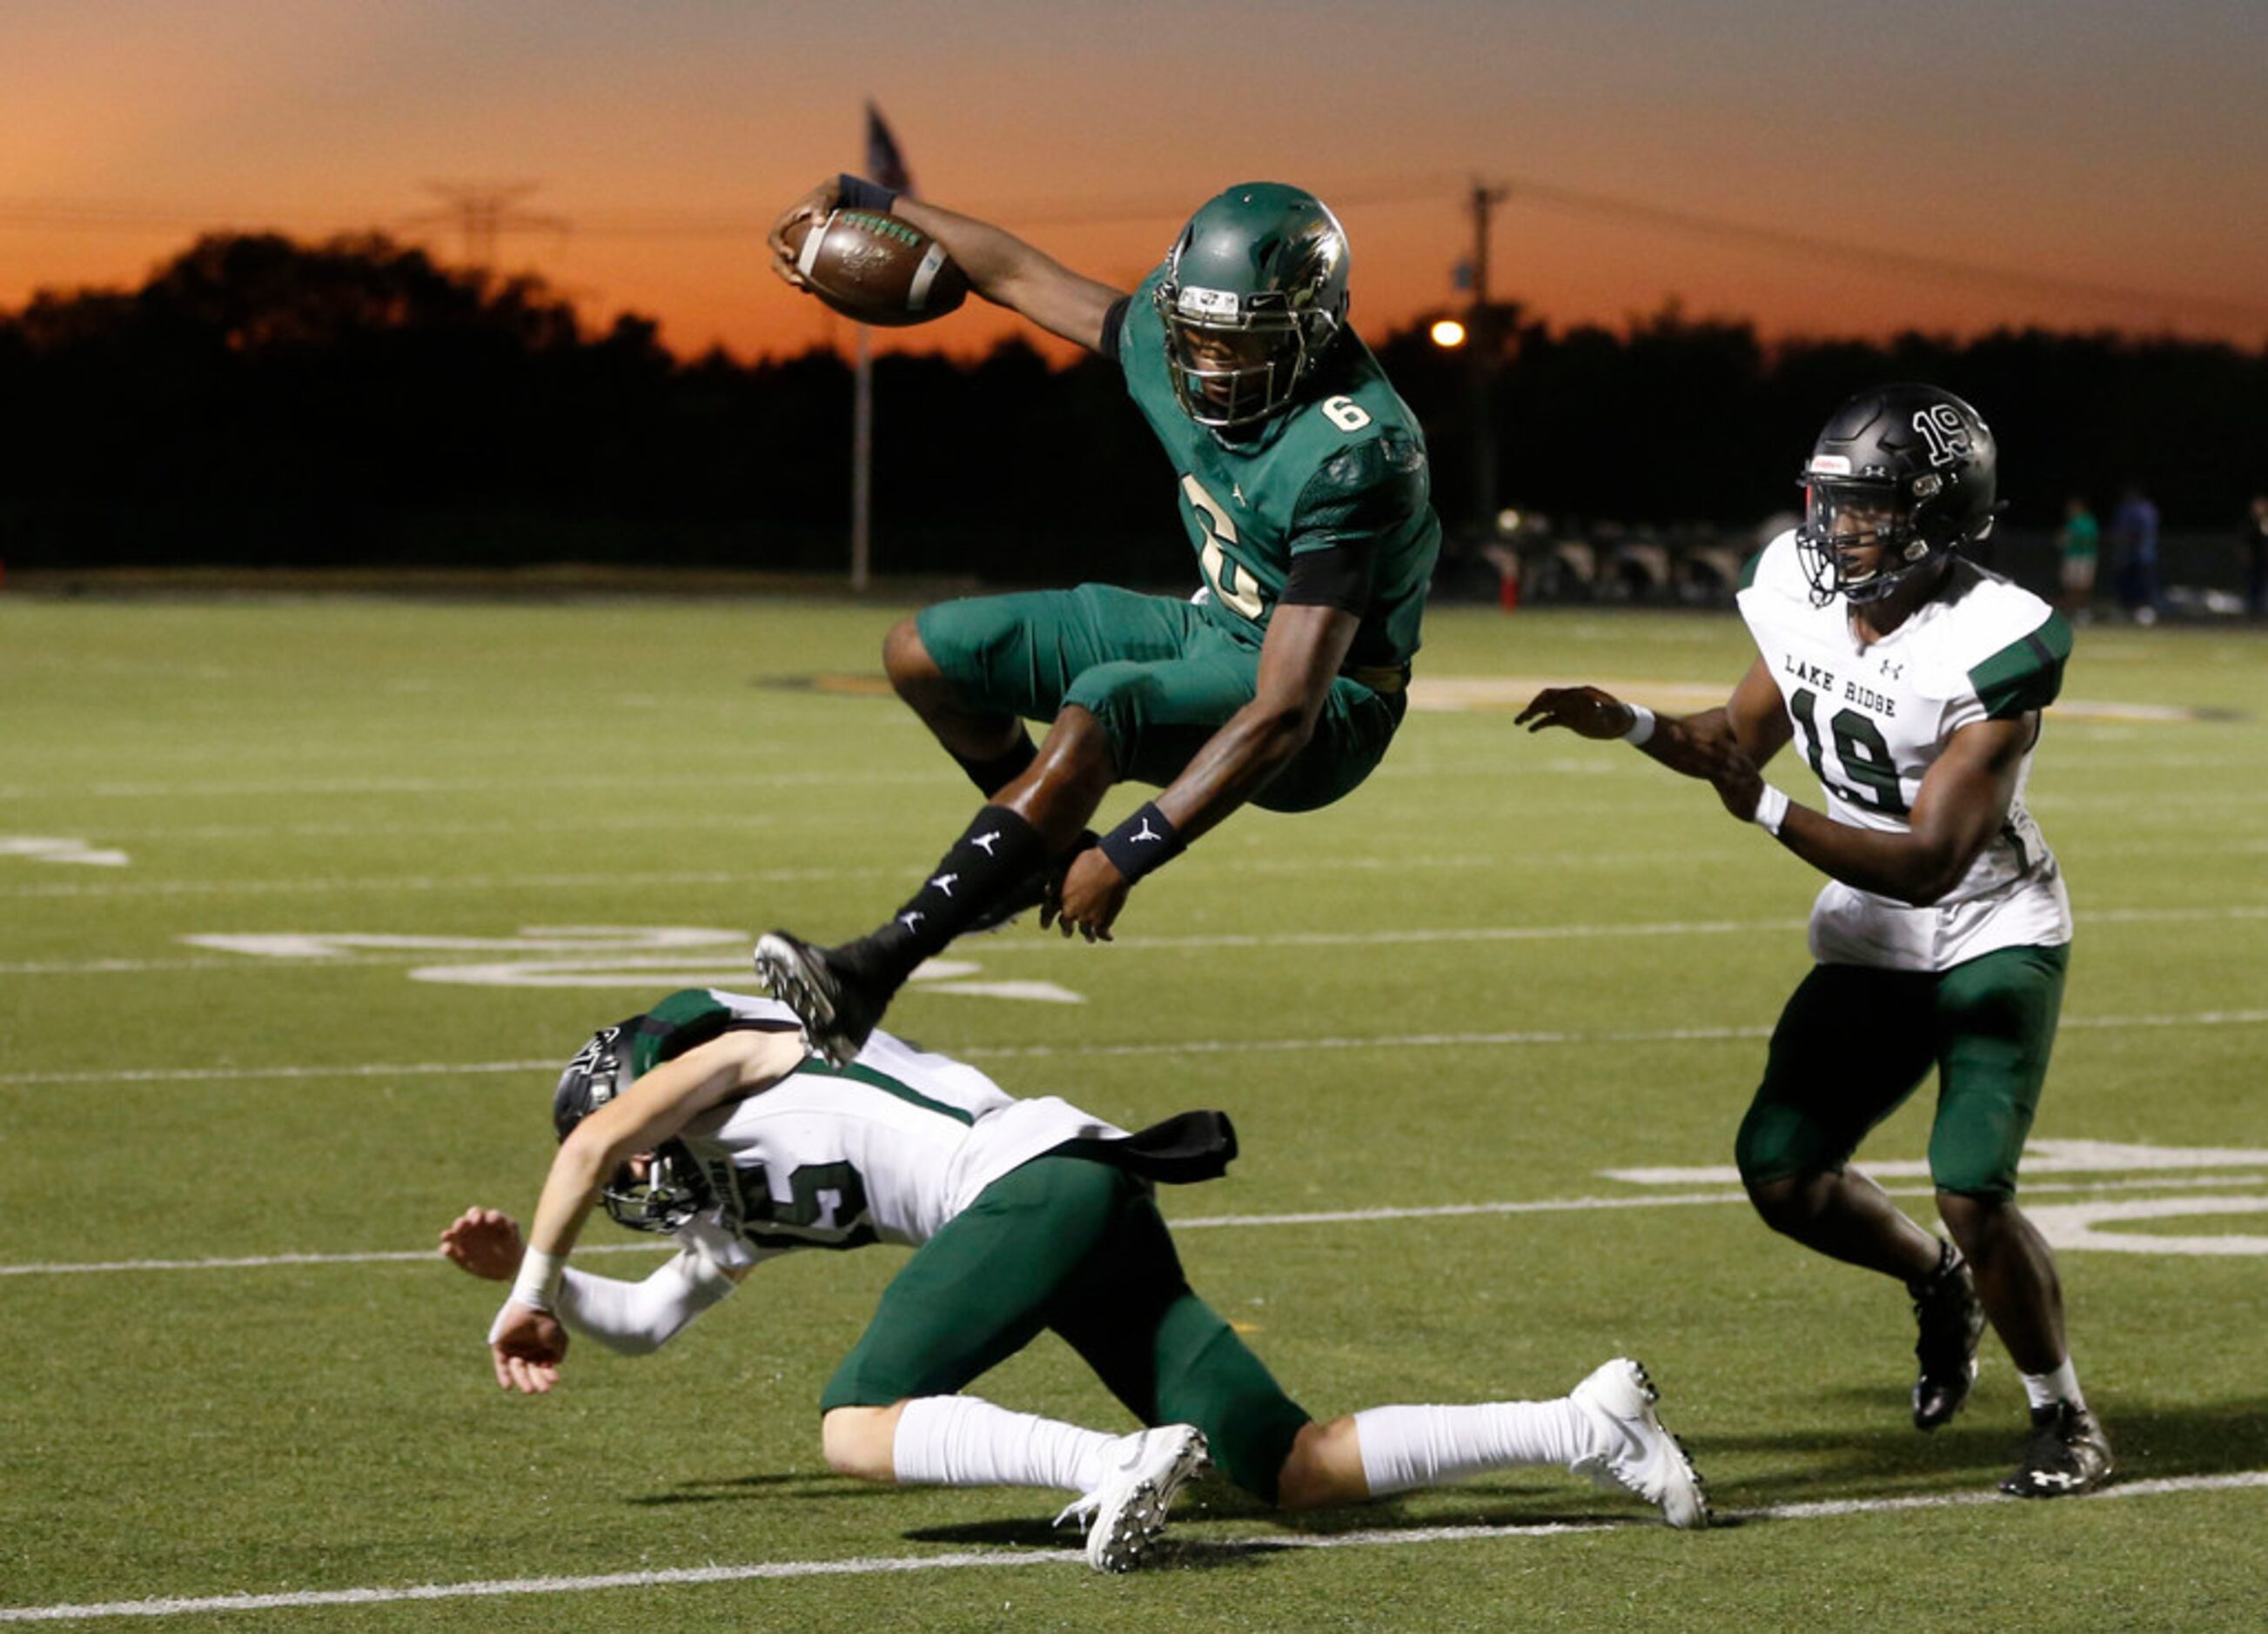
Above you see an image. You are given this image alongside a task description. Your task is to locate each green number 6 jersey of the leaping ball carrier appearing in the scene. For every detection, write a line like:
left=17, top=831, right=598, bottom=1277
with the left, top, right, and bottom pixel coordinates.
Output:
left=1104, top=267, right=1440, bottom=691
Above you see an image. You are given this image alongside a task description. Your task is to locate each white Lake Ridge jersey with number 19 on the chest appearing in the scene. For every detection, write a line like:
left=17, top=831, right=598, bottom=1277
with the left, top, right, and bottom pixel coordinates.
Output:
left=1740, top=531, right=2070, bottom=970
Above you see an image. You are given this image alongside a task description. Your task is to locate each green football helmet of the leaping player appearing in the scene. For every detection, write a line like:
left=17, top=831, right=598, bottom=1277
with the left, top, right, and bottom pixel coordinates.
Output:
left=1157, top=181, right=1347, bottom=431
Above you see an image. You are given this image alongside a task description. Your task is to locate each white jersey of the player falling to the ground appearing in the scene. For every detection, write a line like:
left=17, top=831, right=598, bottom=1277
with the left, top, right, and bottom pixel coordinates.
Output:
left=657, top=990, right=1125, bottom=1269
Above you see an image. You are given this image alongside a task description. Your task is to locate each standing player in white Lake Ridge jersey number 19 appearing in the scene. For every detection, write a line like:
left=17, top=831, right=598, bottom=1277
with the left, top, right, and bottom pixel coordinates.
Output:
left=1517, top=385, right=2111, bottom=1498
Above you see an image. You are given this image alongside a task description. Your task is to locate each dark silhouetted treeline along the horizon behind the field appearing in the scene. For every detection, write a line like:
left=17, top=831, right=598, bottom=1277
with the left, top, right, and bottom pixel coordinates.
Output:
left=0, top=233, right=2268, bottom=582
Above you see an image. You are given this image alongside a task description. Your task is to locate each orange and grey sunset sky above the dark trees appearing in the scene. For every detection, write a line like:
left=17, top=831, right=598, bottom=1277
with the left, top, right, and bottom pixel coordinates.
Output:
left=0, top=0, right=2268, bottom=356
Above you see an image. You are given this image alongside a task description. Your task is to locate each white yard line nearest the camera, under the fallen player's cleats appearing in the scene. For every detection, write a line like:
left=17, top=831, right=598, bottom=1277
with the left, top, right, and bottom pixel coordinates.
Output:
left=0, top=1469, right=2268, bottom=1623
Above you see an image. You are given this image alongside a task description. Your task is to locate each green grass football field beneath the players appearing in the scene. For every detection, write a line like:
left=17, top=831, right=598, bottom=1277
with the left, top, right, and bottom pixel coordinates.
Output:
left=0, top=599, right=2268, bottom=1630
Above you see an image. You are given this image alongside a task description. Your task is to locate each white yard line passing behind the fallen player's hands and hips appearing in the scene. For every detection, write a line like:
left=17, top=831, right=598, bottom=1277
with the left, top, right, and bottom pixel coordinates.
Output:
left=0, top=1174, right=2268, bottom=1276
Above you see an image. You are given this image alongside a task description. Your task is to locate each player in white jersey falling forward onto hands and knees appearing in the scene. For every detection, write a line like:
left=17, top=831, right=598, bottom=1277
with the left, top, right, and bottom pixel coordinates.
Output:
left=442, top=988, right=1708, bottom=1570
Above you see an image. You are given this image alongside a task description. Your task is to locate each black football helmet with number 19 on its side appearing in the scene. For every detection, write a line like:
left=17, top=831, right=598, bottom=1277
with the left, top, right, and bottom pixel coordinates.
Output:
left=1796, top=385, right=2000, bottom=607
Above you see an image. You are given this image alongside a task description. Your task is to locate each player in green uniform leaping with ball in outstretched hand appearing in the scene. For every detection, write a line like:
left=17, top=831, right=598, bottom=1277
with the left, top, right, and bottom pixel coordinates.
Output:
left=755, top=177, right=1440, bottom=1061
